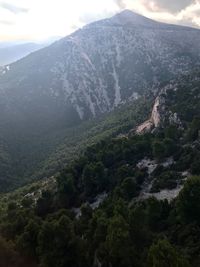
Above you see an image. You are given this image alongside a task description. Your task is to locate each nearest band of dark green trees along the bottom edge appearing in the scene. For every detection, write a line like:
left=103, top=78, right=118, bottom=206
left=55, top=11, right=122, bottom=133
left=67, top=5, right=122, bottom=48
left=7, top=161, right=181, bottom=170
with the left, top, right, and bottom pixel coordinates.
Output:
left=0, top=177, right=200, bottom=267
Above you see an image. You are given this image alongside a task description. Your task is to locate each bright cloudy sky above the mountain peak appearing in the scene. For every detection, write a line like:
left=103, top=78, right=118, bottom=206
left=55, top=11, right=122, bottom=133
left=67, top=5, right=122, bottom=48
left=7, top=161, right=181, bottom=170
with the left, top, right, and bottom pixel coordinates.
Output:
left=0, top=0, right=200, bottom=42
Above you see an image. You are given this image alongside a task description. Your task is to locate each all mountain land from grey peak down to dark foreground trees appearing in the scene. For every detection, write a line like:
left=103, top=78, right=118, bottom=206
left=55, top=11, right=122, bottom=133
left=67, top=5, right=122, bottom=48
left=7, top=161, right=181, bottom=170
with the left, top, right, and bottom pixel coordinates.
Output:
left=0, top=11, right=200, bottom=267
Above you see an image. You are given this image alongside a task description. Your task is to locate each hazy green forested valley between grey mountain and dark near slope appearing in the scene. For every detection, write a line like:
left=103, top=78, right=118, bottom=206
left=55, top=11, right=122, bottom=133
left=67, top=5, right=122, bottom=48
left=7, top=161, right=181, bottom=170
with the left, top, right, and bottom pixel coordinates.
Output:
left=0, top=95, right=153, bottom=192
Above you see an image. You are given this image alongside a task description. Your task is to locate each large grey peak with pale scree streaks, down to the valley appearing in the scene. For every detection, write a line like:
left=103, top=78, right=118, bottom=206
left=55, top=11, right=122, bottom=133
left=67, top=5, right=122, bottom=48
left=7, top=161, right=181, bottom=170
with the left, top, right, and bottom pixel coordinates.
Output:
left=0, top=10, right=200, bottom=191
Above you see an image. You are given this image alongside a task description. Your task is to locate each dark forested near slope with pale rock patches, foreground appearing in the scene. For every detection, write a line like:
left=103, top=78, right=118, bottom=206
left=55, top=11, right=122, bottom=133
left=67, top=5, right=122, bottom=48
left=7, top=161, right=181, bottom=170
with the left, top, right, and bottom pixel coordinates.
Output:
left=0, top=73, right=200, bottom=267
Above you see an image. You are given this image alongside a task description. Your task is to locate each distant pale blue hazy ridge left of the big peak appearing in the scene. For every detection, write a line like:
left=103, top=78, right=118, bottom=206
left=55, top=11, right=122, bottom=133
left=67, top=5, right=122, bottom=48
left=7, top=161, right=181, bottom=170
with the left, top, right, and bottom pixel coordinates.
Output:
left=0, top=43, right=44, bottom=66
